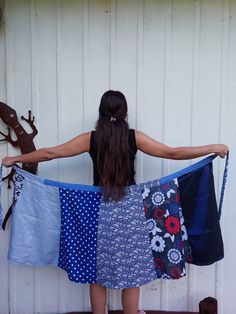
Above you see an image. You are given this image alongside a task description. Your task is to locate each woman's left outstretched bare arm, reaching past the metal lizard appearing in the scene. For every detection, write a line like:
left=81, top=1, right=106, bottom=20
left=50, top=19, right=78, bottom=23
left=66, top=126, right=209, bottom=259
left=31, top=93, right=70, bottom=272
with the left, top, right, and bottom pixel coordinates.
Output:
left=2, top=132, right=91, bottom=167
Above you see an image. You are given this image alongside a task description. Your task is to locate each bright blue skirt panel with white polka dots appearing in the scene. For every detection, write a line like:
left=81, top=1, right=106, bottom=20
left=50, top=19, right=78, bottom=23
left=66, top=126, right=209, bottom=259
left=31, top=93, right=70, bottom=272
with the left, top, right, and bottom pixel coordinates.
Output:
left=58, top=189, right=101, bottom=283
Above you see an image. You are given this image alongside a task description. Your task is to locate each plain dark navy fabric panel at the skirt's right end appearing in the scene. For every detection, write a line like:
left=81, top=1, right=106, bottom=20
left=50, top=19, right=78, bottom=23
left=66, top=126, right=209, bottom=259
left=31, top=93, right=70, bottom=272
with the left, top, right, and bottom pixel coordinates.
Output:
left=178, top=163, right=224, bottom=265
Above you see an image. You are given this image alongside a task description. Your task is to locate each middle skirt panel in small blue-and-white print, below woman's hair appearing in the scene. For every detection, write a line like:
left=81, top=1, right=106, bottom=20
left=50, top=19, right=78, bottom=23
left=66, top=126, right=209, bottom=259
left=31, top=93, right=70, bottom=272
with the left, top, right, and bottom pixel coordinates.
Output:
left=97, top=184, right=157, bottom=289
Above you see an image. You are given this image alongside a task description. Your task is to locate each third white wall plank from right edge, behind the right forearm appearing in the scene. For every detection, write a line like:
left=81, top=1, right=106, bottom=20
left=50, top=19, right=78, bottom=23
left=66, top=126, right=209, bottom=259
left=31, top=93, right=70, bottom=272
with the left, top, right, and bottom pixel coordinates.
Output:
left=161, top=1, right=193, bottom=311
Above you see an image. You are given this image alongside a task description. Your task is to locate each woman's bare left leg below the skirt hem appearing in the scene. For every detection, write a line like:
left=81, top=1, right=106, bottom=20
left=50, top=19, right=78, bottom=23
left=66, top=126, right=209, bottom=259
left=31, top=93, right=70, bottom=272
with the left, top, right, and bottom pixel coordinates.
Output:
left=90, top=284, right=107, bottom=314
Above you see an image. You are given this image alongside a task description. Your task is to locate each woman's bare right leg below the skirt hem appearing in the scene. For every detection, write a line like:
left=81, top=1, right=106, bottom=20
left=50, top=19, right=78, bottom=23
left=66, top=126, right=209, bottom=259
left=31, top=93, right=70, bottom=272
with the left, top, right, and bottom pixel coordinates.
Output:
left=122, top=288, right=139, bottom=314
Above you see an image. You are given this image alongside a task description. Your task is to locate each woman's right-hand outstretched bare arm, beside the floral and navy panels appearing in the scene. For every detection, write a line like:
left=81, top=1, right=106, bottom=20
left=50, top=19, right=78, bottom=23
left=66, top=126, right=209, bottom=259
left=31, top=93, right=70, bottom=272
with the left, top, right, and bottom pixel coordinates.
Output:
left=135, top=130, right=228, bottom=159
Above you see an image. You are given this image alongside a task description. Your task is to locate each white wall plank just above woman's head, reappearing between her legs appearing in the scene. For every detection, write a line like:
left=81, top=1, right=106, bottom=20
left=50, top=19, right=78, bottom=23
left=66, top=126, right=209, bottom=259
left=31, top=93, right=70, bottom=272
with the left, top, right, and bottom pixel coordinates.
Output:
left=108, top=0, right=139, bottom=310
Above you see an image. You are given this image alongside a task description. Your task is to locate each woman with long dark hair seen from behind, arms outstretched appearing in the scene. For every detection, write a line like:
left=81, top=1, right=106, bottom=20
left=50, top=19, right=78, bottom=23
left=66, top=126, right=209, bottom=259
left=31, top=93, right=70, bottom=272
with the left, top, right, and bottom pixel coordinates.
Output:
left=2, top=90, right=228, bottom=314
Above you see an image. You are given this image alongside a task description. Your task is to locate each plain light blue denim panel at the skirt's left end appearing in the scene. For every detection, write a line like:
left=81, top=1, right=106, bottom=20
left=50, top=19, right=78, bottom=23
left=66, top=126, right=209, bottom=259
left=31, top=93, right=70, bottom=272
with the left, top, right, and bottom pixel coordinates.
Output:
left=8, top=168, right=61, bottom=266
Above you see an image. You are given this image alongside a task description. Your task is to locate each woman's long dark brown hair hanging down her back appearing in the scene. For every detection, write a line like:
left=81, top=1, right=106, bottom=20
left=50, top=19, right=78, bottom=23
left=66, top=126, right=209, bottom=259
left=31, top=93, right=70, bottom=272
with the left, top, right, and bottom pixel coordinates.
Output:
left=96, top=90, right=130, bottom=201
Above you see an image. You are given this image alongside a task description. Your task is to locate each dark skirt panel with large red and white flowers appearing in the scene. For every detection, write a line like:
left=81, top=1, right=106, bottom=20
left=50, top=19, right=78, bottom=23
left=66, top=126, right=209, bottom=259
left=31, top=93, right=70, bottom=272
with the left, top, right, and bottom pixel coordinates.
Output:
left=143, top=179, right=191, bottom=279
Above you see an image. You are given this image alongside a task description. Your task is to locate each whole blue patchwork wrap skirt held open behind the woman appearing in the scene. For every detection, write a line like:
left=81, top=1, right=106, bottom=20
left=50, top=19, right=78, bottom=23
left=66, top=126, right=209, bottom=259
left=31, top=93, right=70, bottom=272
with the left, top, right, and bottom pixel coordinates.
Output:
left=0, top=156, right=228, bottom=289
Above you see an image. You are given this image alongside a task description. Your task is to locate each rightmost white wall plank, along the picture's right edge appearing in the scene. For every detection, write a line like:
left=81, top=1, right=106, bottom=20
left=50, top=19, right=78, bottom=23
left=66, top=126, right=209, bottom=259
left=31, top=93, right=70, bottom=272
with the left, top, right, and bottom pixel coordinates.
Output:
left=216, top=1, right=236, bottom=314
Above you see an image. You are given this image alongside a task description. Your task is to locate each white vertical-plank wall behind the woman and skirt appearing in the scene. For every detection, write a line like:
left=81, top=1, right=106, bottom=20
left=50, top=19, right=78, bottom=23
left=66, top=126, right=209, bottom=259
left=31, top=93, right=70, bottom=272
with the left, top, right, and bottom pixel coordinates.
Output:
left=0, top=0, right=236, bottom=314
